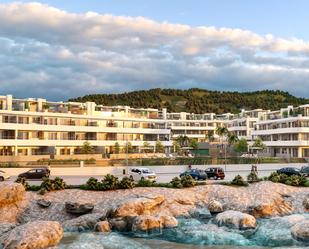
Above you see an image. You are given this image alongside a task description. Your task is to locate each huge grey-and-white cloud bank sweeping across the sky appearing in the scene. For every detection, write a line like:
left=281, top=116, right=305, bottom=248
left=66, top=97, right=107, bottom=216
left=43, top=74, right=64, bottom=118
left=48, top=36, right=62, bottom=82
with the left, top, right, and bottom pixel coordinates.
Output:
left=0, top=3, right=309, bottom=100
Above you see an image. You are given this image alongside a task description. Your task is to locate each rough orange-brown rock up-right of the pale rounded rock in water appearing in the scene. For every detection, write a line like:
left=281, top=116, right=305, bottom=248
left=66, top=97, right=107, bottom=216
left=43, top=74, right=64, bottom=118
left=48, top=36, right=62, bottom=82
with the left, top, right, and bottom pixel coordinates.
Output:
left=249, top=199, right=293, bottom=218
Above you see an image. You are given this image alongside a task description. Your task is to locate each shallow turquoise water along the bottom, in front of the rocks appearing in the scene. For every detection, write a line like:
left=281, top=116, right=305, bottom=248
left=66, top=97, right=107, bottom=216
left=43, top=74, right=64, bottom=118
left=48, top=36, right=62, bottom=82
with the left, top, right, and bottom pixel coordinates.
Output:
left=57, top=215, right=309, bottom=249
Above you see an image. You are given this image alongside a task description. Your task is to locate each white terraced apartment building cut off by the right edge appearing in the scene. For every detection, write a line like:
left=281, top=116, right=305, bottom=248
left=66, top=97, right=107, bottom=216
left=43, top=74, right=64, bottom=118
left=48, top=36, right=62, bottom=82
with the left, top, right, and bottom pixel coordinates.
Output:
left=252, top=105, right=309, bottom=157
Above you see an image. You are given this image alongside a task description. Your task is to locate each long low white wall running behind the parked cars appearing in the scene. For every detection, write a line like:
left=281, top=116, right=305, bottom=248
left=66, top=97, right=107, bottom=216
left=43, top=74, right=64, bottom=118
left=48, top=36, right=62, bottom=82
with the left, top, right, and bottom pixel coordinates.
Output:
left=4, top=163, right=305, bottom=177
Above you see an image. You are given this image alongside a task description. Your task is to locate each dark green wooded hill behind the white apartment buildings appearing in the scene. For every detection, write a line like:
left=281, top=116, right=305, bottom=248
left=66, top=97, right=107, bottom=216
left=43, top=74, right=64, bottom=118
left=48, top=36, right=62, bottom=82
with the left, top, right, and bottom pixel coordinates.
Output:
left=69, top=88, right=309, bottom=114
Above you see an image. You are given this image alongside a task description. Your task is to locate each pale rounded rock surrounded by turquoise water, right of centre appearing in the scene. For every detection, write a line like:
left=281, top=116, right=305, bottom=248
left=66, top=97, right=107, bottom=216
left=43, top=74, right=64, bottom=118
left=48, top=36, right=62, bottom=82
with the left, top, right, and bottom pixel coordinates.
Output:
left=215, top=210, right=256, bottom=229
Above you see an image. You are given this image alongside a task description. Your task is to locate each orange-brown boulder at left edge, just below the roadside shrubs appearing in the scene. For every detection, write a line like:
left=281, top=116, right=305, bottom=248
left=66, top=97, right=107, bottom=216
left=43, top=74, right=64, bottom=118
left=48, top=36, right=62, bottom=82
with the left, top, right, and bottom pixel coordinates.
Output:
left=0, top=182, right=26, bottom=207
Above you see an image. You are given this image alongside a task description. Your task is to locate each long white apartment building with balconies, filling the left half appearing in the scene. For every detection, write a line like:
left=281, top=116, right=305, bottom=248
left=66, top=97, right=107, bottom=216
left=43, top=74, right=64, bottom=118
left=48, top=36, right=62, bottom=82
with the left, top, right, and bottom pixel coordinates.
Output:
left=0, top=95, right=172, bottom=155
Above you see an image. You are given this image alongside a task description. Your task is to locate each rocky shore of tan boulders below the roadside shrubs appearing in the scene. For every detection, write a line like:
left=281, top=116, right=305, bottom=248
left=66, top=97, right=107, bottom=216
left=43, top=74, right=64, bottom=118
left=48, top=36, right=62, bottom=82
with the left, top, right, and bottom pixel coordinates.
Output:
left=0, top=181, right=309, bottom=249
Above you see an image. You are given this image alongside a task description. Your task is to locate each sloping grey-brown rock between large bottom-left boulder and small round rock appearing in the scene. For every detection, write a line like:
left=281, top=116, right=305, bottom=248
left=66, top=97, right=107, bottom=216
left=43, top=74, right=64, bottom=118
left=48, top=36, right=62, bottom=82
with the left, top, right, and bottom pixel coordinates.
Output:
left=62, top=213, right=105, bottom=232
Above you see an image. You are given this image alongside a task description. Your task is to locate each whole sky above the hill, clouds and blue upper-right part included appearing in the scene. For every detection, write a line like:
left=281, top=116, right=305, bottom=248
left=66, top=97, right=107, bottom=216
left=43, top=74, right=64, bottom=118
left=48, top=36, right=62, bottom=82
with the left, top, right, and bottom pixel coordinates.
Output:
left=0, top=0, right=309, bottom=100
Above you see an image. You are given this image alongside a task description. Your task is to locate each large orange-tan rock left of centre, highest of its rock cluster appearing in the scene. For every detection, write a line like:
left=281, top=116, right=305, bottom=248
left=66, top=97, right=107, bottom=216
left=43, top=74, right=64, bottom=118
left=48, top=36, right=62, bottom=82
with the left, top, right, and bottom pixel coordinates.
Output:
left=113, top=195, right=165, bottom=217
